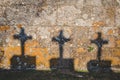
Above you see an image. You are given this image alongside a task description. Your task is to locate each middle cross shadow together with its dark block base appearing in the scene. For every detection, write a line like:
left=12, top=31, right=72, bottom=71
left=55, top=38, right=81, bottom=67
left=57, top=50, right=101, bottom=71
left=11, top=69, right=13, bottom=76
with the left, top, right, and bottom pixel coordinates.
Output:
left=50, top=30, right=74, bottom=70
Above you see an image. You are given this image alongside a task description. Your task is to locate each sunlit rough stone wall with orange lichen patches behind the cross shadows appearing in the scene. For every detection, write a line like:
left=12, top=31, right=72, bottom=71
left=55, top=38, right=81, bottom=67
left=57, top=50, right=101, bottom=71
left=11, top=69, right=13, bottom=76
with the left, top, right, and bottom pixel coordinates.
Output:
left=0, top=0, right=120, bottom=70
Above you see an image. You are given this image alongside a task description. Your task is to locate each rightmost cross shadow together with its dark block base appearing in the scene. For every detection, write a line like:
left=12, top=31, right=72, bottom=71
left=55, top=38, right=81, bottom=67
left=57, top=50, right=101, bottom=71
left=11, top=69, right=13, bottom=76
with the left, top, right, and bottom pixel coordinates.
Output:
left=87, top=32, right=112, bottom=72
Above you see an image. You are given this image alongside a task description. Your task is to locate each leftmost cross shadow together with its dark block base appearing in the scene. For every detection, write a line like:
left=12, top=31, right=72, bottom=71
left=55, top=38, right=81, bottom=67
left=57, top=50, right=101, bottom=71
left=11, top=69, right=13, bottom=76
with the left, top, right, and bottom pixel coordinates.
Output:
left=11, top=28, right=36, bottom=70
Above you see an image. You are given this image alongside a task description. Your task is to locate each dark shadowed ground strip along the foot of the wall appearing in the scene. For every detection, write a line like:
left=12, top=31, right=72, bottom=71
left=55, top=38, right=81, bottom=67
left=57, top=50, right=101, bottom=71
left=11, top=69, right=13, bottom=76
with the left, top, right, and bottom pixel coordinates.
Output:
left=0, top=70, right=120, bottom=80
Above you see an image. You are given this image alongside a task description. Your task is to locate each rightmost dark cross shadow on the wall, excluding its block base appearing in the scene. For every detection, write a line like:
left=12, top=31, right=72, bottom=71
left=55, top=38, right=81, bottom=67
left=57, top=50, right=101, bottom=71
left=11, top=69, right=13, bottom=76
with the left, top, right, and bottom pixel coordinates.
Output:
left=91, top=32, right=108, bottom=62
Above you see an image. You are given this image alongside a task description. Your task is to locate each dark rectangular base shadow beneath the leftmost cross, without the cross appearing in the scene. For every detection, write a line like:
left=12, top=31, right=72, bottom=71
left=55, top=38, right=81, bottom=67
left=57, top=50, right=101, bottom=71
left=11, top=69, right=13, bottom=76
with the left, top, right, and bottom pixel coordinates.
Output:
left=11, top=56, right=36, bottom=70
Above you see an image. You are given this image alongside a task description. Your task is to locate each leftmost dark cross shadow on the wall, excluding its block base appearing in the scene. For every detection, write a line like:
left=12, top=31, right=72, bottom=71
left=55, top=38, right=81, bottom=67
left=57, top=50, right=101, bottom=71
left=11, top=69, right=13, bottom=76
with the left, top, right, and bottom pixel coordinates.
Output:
left=13, top=28, right=32, bottom=56
